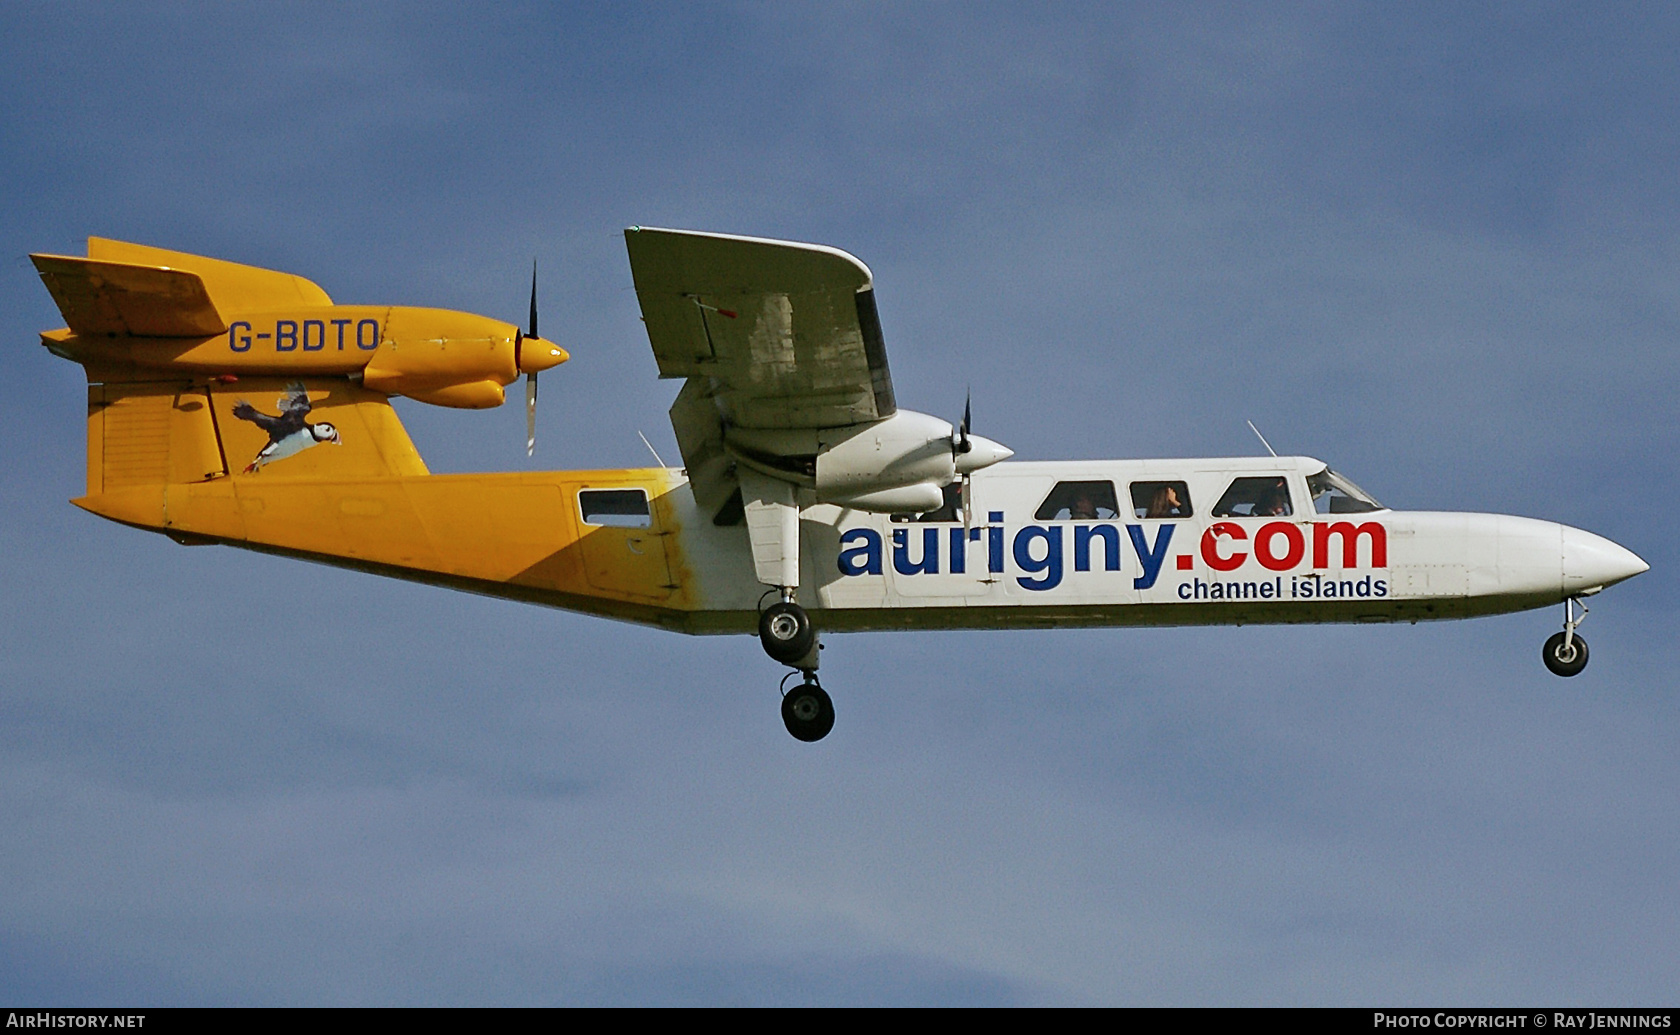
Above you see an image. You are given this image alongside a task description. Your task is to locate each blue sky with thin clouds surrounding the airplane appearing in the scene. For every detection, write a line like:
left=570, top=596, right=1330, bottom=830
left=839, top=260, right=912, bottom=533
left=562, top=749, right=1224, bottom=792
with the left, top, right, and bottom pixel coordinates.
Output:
left=0, top=3, right=1680, bottom=1005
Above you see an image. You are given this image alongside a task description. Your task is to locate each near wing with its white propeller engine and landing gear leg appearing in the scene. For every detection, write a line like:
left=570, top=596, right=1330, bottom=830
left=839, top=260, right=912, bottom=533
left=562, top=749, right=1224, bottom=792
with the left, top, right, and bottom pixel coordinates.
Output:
left=625, top=227, right=1010, bottom=672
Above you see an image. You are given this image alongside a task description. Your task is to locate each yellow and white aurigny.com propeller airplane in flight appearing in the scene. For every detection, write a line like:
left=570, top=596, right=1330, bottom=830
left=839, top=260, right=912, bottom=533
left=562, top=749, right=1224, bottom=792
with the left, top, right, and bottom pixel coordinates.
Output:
left=32, top=227, right=1648, bottom=741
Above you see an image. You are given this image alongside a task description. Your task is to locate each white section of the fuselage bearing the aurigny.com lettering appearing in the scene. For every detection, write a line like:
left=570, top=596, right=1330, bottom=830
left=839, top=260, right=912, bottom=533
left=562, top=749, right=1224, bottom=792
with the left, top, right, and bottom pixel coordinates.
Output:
left=661, top=457, right=1646, bottom=632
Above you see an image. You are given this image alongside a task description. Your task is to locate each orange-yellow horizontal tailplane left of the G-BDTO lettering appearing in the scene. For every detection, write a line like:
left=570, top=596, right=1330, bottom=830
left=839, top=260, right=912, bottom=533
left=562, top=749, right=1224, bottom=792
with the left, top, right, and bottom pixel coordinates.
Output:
left=30, top=255, right=227, bottom=338
